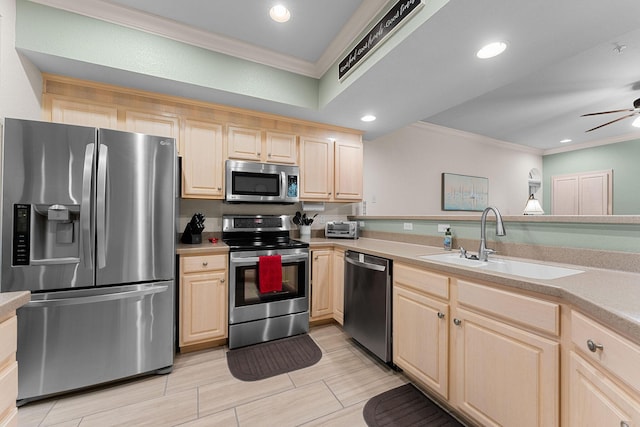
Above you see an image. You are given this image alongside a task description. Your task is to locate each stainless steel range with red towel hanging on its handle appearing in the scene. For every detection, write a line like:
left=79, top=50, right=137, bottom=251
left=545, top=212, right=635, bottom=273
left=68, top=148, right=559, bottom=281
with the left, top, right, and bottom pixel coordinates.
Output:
left=222, top=215, right=309, bottom=349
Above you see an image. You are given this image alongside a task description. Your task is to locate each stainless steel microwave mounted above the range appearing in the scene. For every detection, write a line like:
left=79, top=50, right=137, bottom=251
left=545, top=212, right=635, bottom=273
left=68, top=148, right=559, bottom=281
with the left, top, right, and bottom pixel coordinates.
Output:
left=225, top=160, right=300, bottom=204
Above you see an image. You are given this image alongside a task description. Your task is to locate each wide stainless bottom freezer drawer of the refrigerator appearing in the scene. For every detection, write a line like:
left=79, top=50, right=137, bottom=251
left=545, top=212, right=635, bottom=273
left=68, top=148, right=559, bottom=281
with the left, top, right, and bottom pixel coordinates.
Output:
left=17, top=281, right=174, bottom=403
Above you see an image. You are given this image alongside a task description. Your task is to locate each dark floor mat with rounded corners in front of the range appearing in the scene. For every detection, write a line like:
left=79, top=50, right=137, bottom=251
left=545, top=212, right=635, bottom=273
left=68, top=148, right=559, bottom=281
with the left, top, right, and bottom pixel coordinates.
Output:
left=227, top=334, right=322, bottom=381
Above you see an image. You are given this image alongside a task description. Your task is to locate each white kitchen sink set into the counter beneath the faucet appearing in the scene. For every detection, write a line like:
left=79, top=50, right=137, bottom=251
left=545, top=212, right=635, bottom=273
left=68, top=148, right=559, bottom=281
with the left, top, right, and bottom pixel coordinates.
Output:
left=418, top=253, right=584, bottom=280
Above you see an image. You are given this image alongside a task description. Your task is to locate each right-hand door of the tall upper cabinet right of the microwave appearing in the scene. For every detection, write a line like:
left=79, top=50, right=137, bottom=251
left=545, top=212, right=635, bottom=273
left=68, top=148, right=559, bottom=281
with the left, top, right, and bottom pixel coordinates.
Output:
left=335, top=141, right=363, bottom=200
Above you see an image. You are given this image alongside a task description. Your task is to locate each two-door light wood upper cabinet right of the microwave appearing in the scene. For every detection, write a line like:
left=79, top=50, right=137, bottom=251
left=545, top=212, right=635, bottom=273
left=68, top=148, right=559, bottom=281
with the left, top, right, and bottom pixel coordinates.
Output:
left=300, top=137, right=363, bottom=202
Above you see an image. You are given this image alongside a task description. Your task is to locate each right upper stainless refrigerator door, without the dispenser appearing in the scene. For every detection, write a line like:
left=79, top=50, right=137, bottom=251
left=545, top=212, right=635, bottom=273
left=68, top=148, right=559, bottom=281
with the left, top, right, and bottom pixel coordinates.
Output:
left=96, top=129, right=176, bottom=285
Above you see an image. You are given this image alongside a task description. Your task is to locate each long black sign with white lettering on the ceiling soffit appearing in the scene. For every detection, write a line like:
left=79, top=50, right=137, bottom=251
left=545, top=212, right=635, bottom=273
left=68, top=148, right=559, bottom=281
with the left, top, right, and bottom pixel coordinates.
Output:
left=338, top=0, right=423, bottom=79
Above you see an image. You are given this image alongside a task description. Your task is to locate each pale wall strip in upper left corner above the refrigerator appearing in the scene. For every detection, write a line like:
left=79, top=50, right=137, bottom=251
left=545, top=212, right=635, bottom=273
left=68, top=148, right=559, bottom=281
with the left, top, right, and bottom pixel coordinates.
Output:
left=0, top=0, right=42, bottom=120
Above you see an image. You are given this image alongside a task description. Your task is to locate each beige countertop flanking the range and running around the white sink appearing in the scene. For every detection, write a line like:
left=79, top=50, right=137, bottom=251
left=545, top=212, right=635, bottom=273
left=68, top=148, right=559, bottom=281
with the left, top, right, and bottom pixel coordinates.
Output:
left=177, top=238, right=640, bottom=344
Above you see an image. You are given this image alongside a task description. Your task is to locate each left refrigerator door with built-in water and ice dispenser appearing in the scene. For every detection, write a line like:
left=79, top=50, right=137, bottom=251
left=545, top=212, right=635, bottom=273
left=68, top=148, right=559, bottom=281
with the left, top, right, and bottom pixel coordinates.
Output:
left=0, top=119, right=96, bottom=292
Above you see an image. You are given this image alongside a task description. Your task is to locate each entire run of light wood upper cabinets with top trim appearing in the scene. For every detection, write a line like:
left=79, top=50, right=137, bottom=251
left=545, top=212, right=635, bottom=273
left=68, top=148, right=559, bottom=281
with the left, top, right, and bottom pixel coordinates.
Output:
left=42, top=74, right=363, bottom=202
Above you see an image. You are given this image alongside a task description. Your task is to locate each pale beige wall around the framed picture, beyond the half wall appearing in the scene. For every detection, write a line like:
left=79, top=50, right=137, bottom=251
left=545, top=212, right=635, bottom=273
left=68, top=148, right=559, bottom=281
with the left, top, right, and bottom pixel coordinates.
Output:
left=364, top=122, right=544, bottom=216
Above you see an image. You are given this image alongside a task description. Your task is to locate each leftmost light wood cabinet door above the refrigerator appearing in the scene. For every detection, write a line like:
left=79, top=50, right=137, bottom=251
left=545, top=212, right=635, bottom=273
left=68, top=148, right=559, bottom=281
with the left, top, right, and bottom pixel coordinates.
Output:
left=50, top=98, right=118, bottom=129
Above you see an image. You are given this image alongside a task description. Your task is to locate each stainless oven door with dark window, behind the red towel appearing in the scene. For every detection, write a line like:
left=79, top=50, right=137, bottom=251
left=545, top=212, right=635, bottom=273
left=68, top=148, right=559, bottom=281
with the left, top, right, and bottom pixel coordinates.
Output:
left=229, top=249, right=309, bottom=325
